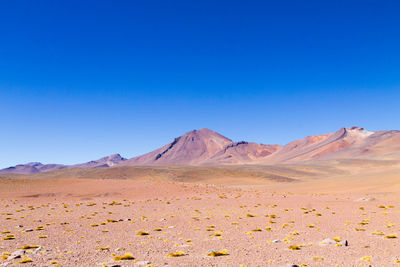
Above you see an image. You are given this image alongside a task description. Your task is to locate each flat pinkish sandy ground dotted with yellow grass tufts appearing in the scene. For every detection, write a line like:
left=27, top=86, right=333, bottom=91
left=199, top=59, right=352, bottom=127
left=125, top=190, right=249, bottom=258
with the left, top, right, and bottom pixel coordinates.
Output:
left=0, top=162, right=400, bottom=266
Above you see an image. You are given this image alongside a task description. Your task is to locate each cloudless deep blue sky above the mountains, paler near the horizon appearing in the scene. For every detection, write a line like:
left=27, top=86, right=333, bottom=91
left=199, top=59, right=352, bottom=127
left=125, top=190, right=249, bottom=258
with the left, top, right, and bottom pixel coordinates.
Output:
left=0, top=0, right=400, bottom=167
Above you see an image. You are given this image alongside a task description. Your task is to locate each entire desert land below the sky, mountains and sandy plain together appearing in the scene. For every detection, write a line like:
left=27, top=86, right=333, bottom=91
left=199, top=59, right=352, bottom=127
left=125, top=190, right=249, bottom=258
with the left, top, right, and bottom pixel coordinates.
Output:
left=0, top=127, right=400, bottom=266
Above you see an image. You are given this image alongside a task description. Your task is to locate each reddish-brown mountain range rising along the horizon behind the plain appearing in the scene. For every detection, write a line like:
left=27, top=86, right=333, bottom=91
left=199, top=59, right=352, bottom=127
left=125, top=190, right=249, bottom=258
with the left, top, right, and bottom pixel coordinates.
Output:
left=0, top=127, right=400, bottom=174
